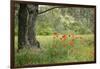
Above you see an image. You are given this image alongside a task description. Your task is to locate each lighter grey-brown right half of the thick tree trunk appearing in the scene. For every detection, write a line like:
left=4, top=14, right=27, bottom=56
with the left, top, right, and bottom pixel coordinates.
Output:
left=26, top=4, right=39, bottom=47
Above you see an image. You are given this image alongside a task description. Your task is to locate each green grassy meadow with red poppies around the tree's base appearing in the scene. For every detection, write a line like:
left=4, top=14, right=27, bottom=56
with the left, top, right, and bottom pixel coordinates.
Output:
left=15, top=35, right=94, bottom=66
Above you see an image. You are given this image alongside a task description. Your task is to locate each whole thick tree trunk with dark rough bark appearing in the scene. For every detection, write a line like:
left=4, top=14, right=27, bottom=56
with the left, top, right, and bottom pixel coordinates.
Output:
left=18, top=4, right=40, bottom=49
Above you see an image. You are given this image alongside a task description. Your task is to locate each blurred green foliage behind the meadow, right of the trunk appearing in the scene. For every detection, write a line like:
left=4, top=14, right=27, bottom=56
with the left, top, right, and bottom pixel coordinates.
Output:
left=36, top=6, right=94, bottom=35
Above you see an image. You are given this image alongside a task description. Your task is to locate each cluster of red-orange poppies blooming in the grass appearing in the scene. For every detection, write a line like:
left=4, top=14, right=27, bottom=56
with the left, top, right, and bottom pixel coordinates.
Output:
left=53, top=32, right=82, bottom=48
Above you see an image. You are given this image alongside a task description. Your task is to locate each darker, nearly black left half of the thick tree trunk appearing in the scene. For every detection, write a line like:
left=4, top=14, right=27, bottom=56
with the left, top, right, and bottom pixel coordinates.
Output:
left=18, top=4, right=27, bottom=49
